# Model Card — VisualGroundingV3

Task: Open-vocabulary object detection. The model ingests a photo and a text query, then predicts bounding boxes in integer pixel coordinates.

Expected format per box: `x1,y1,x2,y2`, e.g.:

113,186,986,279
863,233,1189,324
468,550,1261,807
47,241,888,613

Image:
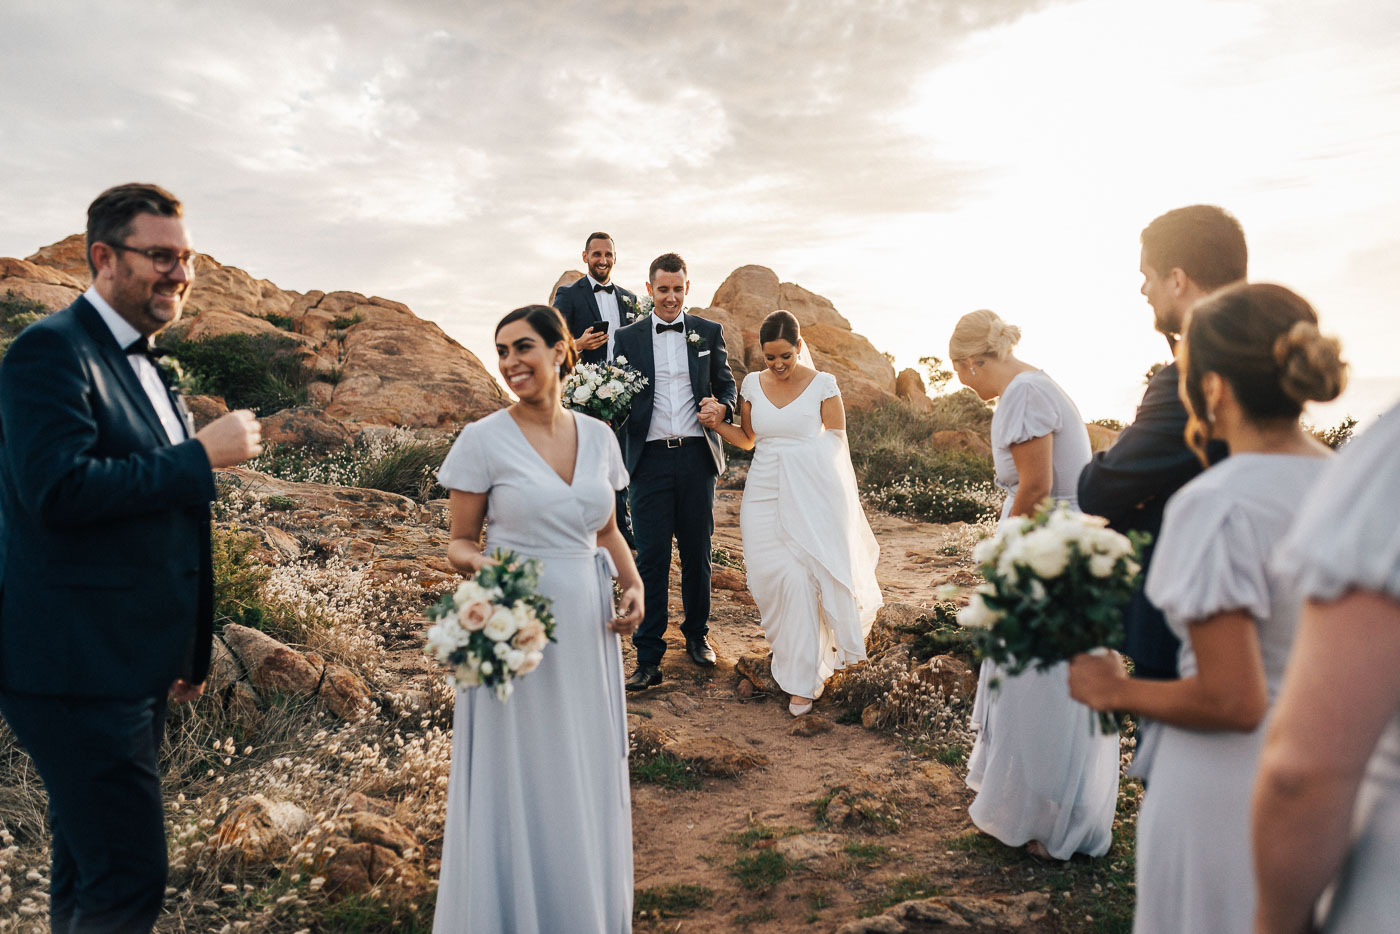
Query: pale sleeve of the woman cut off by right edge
1273,405,1400,601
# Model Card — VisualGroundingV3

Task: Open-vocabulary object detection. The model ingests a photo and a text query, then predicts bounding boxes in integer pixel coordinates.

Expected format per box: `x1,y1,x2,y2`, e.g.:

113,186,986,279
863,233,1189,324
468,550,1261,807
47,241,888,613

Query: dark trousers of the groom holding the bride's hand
629,438,714,665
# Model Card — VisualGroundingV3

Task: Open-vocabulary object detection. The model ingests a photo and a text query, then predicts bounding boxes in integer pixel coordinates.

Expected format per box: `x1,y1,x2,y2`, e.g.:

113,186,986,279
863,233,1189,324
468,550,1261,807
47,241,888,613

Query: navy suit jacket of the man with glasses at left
0,298,216,699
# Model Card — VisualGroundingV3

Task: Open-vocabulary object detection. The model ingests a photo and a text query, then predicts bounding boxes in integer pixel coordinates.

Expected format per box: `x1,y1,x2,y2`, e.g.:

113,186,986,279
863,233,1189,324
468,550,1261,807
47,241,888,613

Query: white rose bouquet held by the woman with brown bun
958,503,1147,732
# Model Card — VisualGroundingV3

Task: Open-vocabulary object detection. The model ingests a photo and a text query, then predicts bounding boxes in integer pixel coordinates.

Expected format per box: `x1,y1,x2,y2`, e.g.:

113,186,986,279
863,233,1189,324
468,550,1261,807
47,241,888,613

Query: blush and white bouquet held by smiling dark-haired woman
423,549,554,702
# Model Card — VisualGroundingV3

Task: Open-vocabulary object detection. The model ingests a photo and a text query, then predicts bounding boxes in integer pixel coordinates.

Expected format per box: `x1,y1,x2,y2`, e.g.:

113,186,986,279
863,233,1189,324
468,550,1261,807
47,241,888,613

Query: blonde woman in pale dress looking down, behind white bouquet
948,311,1119,860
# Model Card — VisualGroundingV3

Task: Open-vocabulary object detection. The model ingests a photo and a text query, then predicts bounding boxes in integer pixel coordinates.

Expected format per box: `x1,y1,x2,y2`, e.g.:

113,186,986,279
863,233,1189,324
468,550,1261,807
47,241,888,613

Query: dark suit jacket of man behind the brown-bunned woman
1079,363,1225,678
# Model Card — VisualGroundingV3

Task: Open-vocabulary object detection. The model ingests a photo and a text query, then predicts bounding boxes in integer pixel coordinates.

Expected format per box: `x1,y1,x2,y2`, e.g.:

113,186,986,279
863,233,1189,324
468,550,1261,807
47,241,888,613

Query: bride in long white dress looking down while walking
701,309,885,717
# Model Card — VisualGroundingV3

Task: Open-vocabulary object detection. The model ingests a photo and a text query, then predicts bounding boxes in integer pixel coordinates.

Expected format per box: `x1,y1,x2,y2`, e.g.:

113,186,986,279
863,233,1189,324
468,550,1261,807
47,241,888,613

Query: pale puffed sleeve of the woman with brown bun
1147,483,1270,627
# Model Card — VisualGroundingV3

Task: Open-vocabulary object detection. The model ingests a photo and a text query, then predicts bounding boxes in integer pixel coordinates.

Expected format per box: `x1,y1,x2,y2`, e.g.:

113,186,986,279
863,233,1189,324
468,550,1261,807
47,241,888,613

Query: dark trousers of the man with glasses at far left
0,693,167,934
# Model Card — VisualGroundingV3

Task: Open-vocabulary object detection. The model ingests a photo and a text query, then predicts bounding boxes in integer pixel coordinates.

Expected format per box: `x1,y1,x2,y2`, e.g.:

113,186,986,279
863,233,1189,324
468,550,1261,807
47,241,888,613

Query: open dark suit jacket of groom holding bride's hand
615,312,736,475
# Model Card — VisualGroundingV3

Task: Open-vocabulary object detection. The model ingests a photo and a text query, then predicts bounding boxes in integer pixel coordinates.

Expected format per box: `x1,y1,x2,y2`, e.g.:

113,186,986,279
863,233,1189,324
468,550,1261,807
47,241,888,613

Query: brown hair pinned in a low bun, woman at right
1179,283,1347,459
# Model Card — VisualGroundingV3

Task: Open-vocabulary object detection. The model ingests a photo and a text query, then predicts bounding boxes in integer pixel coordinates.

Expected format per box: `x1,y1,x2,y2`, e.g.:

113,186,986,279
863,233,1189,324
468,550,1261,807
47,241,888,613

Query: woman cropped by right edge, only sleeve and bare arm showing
1254,394,1400,934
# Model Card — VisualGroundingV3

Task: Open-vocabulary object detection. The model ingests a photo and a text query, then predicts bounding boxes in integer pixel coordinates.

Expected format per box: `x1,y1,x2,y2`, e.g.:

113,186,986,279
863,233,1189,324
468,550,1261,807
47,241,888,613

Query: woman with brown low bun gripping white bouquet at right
1070,284,1344,934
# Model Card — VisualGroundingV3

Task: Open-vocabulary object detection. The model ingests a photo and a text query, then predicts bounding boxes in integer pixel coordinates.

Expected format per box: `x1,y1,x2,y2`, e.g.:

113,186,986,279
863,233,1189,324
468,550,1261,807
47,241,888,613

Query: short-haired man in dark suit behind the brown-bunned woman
1079,204,1249,678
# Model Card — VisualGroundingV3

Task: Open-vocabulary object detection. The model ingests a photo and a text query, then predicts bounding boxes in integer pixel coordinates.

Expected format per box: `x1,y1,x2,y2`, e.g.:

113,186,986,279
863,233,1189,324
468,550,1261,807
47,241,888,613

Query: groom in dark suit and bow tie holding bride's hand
616,253,736,690
